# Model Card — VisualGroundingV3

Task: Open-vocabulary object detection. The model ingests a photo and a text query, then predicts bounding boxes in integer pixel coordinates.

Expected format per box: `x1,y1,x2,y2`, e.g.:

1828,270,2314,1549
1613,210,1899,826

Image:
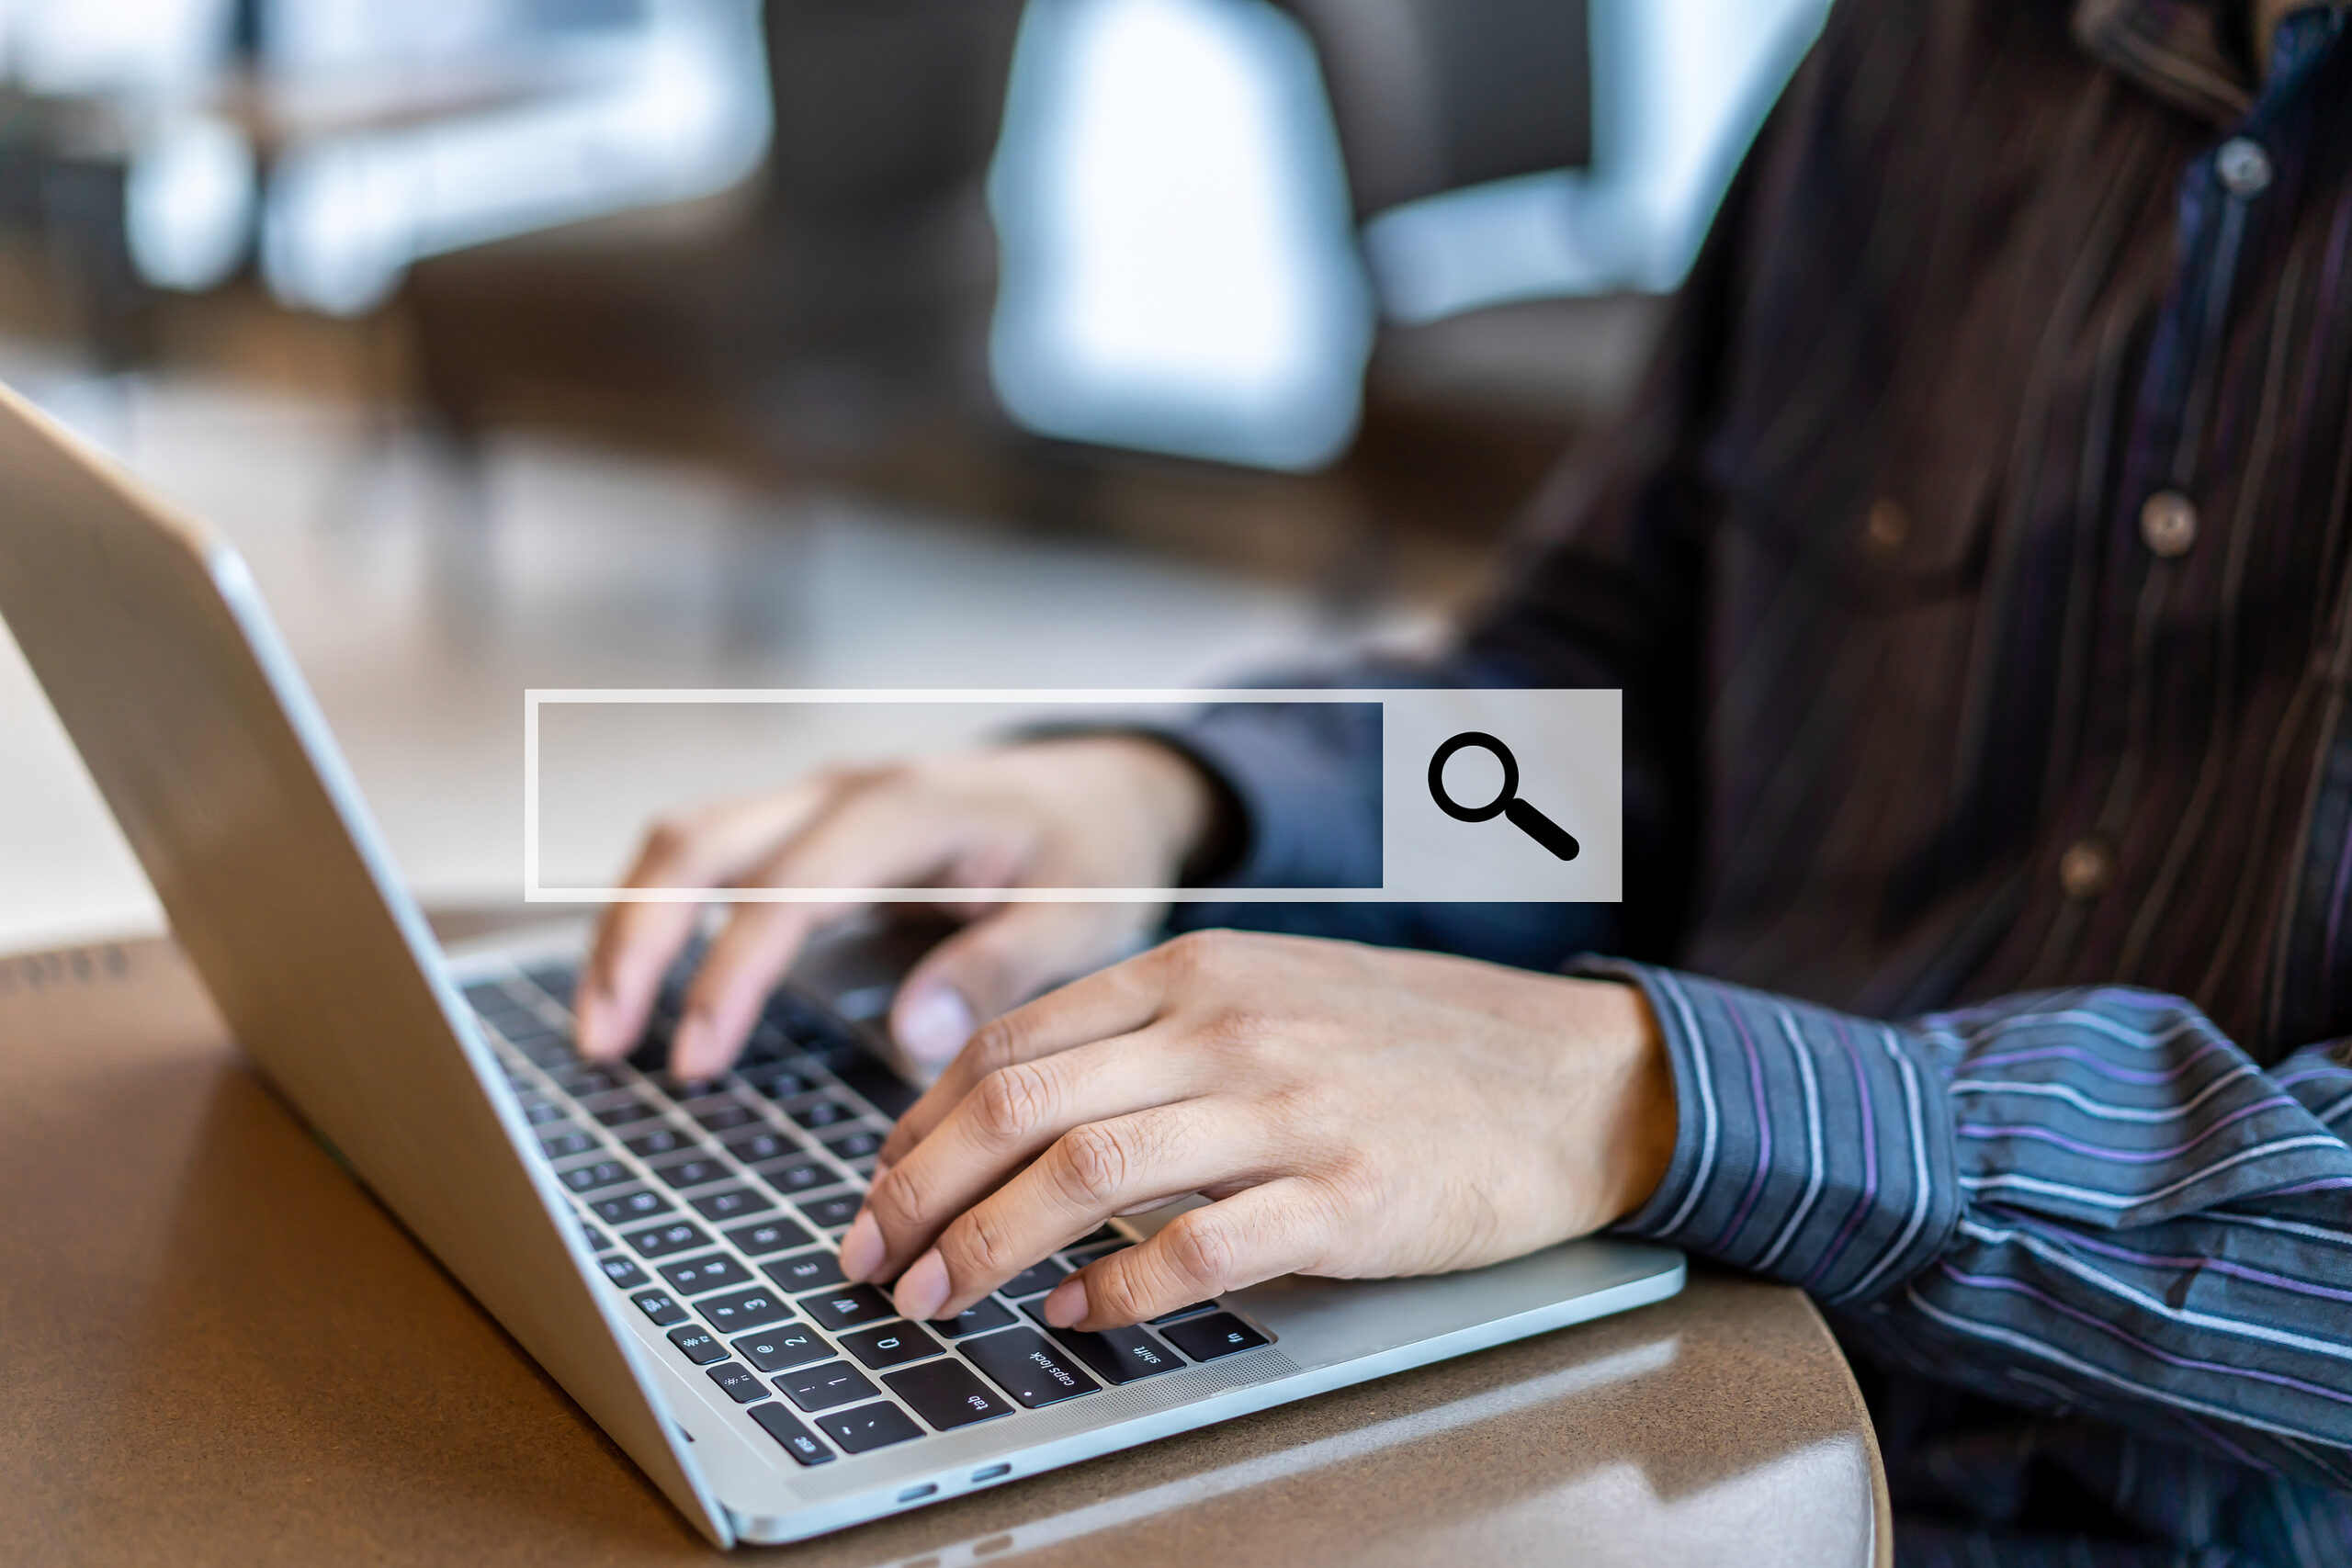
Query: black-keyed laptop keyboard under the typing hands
466,964,1268,1464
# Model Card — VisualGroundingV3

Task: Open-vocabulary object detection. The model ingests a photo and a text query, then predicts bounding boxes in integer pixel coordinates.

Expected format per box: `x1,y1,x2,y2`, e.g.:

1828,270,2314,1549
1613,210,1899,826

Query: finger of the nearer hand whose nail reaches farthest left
842,1034,1204,1279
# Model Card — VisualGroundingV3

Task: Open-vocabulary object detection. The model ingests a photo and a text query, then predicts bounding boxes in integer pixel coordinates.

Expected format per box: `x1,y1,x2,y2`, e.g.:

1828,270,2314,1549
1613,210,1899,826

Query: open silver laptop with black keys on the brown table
0,390,1684,1547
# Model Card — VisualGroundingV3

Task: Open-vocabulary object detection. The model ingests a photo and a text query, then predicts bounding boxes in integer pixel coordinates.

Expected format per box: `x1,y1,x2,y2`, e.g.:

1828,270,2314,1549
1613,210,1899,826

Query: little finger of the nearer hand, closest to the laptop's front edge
1045,1176,1345,1331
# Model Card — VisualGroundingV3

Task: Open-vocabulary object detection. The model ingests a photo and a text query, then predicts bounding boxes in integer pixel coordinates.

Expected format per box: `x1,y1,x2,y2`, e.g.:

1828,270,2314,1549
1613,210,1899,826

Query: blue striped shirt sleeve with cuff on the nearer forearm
1580,962,2352,1488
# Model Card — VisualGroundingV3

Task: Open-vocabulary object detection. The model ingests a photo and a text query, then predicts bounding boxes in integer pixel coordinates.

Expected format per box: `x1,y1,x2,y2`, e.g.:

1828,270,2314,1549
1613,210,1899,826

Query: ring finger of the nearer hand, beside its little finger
894,1100,1270,1321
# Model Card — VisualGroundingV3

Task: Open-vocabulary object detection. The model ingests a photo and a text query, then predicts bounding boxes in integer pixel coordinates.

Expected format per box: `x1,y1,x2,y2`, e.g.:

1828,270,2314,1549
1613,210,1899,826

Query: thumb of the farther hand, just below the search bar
889,903,1150,1067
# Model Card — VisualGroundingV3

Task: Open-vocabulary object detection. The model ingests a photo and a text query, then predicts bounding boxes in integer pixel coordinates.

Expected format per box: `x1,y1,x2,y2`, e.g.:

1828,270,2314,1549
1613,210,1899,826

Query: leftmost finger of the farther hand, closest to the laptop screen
574,778,837,1060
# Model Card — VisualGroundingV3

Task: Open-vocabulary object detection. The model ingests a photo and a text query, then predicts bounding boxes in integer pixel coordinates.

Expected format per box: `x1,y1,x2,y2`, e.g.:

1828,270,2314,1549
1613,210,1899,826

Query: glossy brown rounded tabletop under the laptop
0,926,1889,1568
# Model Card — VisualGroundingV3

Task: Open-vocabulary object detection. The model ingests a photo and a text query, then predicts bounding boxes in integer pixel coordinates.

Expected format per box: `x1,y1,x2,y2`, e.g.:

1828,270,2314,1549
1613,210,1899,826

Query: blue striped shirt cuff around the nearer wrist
1571,959,1964,1304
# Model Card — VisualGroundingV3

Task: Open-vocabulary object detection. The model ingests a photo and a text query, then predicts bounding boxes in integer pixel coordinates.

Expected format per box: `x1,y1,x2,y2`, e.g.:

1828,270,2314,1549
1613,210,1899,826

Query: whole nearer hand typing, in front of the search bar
842,931,1675,1328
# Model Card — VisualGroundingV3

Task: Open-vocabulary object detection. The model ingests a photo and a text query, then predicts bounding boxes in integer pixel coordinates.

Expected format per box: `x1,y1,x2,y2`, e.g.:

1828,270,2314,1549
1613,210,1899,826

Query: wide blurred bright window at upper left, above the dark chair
261,0,769,315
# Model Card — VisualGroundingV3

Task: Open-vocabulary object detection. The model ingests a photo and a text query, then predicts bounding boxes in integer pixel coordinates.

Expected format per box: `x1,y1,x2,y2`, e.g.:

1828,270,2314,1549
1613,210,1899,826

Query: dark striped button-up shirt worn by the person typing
1179,0,2352,1563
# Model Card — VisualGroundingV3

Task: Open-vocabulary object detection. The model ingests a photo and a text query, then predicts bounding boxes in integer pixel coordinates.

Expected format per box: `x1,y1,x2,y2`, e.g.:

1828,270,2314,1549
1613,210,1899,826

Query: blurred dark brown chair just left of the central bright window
404,0,1021,468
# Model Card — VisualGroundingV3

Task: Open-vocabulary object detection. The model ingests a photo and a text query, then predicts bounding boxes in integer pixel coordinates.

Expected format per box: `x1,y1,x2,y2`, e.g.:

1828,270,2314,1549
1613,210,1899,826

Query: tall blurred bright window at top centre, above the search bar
990,0,1371,468
